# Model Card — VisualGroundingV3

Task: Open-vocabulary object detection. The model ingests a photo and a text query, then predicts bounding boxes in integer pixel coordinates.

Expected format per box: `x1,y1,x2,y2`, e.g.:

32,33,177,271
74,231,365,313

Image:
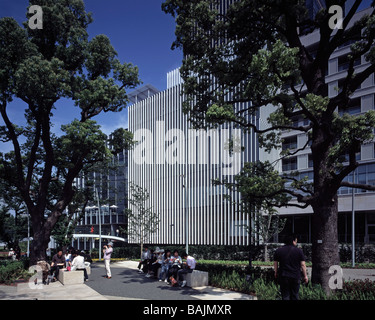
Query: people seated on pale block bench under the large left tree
50,248,91,281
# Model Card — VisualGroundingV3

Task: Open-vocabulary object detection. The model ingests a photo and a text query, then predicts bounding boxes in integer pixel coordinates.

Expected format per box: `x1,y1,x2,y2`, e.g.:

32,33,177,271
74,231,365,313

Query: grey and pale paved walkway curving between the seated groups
0,261,253,300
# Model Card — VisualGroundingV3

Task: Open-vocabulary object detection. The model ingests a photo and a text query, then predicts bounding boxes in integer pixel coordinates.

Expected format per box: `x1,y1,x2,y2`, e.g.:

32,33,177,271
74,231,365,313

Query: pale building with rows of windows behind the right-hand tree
274,9,375,243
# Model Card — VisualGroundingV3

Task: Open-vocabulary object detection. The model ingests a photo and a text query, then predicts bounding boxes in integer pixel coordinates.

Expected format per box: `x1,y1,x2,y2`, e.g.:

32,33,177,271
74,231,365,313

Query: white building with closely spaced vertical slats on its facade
129,70,267,245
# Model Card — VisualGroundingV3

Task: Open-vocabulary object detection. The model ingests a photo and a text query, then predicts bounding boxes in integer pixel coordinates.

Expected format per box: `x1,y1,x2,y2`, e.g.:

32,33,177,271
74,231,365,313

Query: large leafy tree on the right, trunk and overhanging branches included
163,0,375,292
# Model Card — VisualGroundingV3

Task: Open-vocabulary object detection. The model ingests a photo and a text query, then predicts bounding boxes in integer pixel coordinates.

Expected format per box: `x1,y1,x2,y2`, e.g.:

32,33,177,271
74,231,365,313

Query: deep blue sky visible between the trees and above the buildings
0,0,182,152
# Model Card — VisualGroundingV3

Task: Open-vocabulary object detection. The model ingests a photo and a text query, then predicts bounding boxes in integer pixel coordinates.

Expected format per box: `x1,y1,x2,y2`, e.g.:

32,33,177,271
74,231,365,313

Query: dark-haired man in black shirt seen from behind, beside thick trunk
274,235,309,300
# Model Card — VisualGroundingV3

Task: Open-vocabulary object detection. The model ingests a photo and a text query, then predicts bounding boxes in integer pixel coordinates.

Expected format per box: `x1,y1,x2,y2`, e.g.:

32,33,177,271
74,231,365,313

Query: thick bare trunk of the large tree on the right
311,195,340,294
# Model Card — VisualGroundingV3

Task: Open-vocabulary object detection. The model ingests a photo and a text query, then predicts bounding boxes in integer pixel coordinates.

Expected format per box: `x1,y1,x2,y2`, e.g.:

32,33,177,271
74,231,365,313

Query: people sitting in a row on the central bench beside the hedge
138,247,196,287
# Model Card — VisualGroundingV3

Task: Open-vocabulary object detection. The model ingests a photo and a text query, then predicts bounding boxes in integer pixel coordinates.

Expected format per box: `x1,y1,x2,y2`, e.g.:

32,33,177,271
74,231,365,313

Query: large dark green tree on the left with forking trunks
0,0,140,264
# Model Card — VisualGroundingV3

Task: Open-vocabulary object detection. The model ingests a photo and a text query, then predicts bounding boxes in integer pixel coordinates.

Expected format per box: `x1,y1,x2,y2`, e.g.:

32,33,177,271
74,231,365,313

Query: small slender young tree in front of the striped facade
126,183,160,259
